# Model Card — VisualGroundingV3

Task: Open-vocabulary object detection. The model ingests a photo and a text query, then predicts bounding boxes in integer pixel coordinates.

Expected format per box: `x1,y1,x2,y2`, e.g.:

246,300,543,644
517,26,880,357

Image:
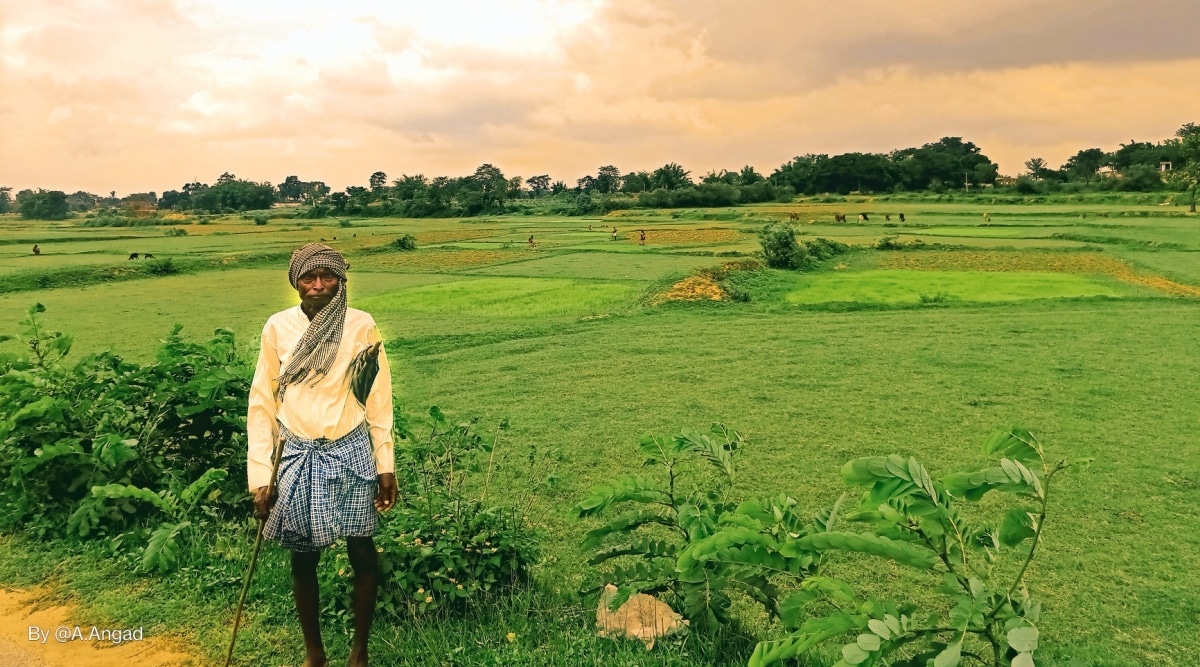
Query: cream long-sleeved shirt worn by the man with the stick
246,306,395,491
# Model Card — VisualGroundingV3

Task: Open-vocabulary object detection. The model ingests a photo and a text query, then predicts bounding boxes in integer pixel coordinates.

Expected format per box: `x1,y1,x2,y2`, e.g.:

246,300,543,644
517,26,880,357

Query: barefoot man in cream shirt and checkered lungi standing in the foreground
246,244,396,667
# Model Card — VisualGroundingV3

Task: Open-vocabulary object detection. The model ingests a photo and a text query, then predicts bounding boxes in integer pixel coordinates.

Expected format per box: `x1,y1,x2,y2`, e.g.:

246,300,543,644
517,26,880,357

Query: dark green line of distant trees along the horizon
0,122,1200,220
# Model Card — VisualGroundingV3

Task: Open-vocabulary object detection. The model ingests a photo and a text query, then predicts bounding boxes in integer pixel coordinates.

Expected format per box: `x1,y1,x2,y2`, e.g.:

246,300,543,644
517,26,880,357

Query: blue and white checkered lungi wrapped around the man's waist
263,422,378,552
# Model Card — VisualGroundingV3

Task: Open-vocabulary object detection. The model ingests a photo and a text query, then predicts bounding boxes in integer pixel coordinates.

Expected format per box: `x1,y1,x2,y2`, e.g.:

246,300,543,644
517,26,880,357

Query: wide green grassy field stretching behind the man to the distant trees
0,194,1200,667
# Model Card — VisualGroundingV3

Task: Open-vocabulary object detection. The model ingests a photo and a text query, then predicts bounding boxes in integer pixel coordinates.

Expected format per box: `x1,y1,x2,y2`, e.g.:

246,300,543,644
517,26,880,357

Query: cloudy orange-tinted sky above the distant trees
0,0,1200,196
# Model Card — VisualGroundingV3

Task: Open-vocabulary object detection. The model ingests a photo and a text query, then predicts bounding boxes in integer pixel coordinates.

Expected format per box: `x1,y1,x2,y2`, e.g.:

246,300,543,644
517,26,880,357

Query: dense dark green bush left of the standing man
0,304,254,536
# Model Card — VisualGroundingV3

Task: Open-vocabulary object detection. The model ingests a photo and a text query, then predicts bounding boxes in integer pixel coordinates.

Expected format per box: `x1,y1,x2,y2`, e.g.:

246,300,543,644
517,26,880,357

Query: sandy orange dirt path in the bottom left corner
0,588,199,667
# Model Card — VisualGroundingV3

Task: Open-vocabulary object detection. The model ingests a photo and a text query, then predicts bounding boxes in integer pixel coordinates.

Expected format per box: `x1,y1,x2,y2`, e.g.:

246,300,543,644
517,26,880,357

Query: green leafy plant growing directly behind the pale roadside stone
576,423,835,629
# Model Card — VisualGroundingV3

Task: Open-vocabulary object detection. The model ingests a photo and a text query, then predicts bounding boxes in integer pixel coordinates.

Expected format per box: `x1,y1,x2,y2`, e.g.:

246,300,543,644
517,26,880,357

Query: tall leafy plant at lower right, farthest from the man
749,428,1070,667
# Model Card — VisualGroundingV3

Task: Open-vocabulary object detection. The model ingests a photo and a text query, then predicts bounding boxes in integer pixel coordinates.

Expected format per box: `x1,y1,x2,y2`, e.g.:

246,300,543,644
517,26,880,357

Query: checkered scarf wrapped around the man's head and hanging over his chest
278,244,349,402
